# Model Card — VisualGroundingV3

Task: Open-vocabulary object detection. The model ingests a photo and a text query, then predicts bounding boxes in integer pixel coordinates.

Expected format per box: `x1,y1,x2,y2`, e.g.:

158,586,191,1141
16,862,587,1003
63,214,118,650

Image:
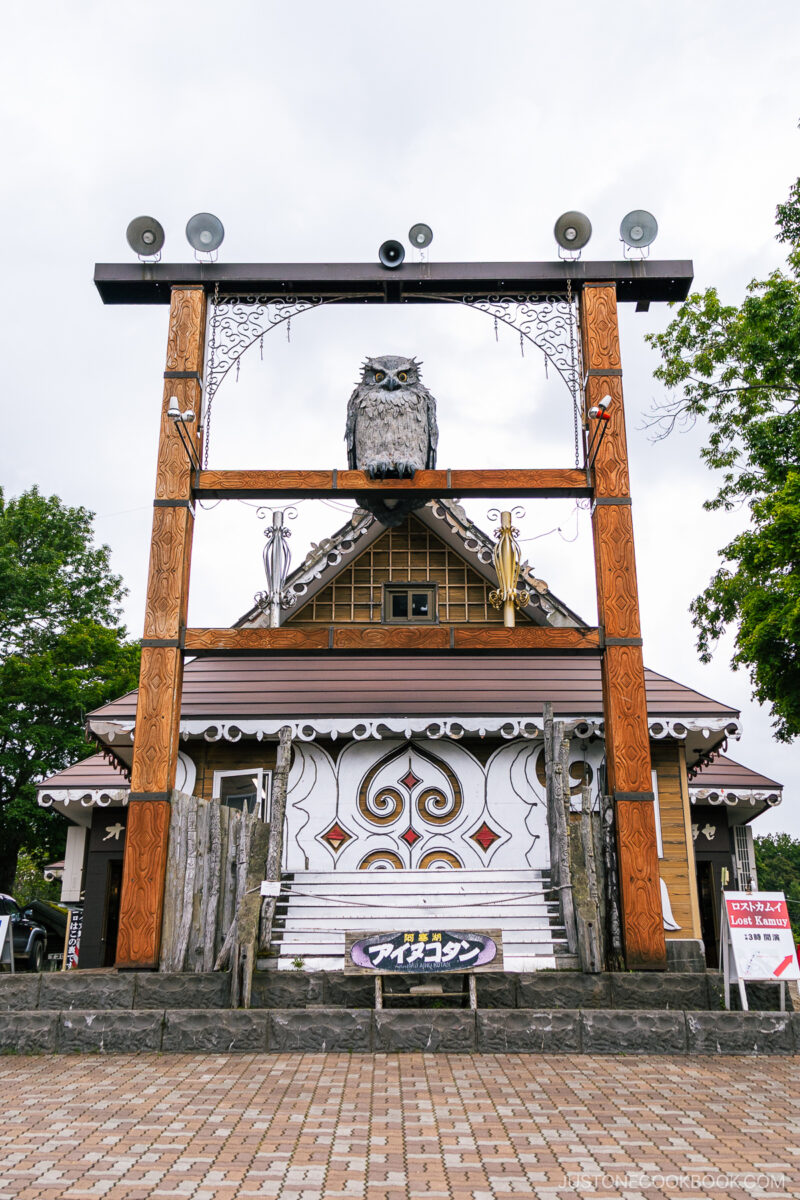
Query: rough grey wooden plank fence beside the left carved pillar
160,792,267,971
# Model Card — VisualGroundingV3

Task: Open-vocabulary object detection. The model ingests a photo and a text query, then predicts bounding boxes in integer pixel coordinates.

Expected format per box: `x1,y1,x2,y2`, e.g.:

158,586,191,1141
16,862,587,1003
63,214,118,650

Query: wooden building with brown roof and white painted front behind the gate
40,500,781,970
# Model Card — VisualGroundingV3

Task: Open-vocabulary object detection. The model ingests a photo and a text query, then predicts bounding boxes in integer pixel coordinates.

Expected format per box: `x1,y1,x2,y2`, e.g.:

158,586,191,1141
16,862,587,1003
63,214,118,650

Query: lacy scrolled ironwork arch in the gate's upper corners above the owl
204,292,583,466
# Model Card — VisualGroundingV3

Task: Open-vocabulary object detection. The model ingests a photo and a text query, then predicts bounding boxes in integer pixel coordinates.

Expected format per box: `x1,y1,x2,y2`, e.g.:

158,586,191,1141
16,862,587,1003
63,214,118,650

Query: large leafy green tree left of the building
0,487,139,892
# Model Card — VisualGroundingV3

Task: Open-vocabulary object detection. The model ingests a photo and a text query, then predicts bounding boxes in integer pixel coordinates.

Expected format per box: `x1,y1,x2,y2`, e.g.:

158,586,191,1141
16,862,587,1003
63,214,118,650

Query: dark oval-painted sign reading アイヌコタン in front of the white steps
344,929,503,974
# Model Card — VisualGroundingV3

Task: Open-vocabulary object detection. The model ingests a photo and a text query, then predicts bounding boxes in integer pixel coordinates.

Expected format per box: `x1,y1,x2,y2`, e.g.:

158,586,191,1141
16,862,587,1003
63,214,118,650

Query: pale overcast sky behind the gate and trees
0,0,800,836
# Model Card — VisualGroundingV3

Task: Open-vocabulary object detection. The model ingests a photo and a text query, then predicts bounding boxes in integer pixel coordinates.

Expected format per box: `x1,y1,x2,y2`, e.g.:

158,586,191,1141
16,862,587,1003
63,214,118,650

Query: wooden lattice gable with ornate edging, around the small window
237,500,585,628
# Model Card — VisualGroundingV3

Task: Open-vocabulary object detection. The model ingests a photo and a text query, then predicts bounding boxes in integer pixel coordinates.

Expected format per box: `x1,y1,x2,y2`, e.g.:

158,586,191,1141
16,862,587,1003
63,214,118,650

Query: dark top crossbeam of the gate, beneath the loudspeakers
95,259,694,305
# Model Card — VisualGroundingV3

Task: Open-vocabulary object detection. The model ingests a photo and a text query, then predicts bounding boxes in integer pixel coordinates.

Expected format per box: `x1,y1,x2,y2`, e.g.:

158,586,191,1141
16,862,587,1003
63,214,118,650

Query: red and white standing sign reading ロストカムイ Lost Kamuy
723,892,800,980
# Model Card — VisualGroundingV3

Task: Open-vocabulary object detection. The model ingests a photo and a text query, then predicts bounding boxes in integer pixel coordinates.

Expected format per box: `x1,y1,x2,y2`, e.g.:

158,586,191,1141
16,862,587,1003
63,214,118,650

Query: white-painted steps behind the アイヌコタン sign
259,870,568,972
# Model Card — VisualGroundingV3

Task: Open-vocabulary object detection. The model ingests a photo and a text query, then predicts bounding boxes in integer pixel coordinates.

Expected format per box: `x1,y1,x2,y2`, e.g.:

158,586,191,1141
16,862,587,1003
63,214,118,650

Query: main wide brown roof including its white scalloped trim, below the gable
89,652,739,764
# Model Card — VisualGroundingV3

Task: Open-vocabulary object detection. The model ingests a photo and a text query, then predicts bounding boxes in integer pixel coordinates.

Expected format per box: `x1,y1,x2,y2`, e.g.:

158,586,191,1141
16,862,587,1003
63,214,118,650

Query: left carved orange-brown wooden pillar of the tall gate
116,287,206,968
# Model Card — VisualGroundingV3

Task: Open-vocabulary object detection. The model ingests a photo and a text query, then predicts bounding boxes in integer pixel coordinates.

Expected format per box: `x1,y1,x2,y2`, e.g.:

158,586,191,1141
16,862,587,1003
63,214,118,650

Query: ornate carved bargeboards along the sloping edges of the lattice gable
236,500,587,629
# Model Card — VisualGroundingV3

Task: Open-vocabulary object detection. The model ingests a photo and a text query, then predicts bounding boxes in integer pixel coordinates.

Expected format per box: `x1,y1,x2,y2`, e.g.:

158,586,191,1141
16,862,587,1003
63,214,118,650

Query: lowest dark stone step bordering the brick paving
0,1008,800,1056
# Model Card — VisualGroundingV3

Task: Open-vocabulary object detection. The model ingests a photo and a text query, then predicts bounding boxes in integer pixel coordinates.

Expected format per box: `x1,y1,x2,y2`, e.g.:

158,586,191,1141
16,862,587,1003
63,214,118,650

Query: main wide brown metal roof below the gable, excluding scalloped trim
90,653,739,720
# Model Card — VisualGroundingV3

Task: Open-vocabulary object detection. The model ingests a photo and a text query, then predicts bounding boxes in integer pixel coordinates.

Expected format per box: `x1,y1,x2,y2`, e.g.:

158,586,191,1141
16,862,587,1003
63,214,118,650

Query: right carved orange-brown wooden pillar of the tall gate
581,283,667,970
